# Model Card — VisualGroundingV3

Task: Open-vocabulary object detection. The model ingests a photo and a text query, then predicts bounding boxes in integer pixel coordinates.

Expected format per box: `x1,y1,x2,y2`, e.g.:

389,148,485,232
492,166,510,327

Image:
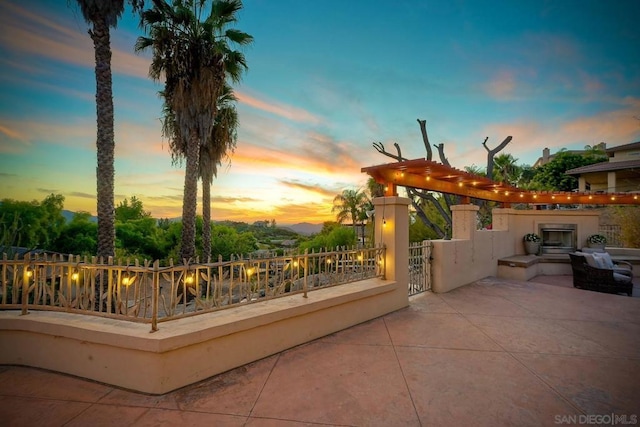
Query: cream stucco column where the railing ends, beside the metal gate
373,196,411,284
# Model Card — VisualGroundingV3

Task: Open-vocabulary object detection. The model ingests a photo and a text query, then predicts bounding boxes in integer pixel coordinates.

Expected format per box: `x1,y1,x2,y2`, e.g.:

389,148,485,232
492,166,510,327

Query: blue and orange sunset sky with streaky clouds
0,0,640,224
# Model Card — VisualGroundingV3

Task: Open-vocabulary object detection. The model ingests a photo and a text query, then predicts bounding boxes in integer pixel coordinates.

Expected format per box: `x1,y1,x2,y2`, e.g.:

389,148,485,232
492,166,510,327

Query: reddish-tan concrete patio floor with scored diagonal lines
0,276,640,427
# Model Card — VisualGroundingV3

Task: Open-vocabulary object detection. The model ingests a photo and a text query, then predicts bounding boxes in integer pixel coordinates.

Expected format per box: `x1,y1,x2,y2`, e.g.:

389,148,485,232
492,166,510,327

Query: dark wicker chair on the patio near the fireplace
569,254,633,296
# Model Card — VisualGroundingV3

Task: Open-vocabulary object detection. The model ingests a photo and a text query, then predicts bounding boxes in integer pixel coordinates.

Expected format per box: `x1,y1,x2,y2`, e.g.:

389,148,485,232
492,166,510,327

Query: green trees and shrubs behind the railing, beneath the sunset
0,194,357,263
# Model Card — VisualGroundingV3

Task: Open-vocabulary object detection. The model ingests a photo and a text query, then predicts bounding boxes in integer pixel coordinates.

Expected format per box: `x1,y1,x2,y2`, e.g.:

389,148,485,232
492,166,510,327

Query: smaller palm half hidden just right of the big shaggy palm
199,85,238,261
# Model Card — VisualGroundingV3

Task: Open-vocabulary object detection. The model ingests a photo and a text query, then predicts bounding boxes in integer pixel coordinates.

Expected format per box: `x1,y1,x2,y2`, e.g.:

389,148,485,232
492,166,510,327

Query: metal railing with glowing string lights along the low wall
0,247,385,331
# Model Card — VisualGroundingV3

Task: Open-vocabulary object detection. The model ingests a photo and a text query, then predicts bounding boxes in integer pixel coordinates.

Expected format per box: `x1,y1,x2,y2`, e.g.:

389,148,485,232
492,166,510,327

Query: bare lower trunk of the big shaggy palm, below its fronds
180,130,200,261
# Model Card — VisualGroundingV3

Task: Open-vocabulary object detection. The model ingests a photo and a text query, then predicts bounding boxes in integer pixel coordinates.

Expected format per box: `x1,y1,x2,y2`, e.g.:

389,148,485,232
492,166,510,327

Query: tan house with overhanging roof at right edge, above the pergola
566,141,640,193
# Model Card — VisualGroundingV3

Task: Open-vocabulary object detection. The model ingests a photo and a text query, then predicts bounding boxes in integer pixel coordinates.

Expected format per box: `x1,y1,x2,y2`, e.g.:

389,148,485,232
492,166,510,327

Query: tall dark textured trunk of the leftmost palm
89,18,115,258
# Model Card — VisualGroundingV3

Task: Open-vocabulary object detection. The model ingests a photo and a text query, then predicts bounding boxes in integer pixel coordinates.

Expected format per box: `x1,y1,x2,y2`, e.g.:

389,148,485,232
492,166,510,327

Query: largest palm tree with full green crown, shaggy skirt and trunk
136,0,253,261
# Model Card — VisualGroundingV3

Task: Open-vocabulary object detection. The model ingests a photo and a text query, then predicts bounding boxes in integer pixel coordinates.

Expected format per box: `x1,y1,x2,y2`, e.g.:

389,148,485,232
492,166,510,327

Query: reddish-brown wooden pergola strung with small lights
361,159,640,207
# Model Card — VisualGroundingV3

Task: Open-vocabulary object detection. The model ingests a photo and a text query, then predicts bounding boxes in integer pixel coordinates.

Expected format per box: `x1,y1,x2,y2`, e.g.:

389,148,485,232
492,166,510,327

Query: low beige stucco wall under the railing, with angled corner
0,279,408,394
